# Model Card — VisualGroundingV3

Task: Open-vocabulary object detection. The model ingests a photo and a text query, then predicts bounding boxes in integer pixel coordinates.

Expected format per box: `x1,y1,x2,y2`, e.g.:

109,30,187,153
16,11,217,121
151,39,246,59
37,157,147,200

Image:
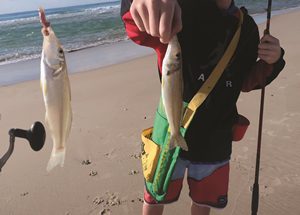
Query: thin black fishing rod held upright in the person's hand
251,0,272,215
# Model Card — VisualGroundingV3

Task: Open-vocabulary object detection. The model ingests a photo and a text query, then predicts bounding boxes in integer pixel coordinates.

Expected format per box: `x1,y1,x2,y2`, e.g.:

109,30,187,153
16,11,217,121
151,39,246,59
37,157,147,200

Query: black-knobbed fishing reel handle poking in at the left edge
0,122,46,172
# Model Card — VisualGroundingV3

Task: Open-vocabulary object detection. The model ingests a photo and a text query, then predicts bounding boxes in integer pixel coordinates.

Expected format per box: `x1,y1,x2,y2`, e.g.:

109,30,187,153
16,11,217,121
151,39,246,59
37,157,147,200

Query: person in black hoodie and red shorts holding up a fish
121,0,285,215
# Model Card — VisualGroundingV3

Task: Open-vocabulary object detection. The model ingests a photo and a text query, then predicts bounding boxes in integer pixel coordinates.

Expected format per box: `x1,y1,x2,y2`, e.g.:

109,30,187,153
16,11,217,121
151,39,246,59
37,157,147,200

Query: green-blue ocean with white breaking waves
0,0,300,66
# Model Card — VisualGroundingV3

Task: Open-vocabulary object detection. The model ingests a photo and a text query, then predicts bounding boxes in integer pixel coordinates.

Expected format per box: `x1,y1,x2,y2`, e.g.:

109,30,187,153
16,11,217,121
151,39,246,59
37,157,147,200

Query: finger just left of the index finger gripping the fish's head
149,1,159,37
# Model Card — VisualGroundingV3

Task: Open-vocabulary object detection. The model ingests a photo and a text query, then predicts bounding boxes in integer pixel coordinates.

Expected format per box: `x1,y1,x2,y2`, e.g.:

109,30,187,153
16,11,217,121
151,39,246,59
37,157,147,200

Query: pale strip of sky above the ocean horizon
0,0,108,14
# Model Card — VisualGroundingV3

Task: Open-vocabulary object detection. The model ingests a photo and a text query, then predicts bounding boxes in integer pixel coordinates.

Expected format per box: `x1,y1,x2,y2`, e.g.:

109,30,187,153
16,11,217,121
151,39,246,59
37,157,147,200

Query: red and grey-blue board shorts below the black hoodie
144,158,229,208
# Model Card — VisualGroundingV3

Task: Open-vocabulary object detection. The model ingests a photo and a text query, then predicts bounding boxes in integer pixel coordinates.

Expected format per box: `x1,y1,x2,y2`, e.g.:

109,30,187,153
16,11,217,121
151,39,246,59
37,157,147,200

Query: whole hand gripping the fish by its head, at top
130,0,182,43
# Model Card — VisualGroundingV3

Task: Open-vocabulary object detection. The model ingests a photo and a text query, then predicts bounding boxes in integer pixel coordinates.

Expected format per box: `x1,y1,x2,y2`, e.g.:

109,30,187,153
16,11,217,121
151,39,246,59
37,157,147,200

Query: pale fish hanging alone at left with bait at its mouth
39,8,72,172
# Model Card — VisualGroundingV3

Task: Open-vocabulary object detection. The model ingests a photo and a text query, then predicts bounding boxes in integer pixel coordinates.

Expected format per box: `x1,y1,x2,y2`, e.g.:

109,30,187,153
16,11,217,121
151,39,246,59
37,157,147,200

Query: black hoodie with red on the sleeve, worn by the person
121,0,285,163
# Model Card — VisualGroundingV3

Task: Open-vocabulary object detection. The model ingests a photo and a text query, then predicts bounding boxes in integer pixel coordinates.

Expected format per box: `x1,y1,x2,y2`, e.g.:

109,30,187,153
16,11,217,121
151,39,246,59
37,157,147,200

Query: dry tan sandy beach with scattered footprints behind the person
0,10,300,215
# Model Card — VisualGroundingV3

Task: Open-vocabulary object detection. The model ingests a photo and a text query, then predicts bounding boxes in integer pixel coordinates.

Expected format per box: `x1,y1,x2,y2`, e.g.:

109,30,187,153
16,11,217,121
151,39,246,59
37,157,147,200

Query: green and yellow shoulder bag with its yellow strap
141,11,243,202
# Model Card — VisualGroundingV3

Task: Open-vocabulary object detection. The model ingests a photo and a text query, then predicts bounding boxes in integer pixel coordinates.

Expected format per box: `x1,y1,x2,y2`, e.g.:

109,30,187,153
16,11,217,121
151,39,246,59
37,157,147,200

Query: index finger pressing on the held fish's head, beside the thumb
159,7,174,43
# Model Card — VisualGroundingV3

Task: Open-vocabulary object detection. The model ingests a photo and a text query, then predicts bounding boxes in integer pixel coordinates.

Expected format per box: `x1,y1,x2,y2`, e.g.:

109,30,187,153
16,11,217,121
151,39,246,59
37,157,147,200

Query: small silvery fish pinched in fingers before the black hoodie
161,35,188,151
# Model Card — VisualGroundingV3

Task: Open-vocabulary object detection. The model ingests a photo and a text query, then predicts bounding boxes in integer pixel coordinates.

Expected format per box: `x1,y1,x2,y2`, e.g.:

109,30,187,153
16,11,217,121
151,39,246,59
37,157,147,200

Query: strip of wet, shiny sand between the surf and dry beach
0,7,300,87
